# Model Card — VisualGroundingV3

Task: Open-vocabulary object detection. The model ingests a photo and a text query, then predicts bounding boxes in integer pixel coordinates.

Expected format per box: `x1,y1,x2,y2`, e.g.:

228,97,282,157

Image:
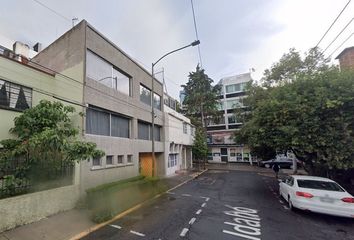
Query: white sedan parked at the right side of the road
279,175,354,218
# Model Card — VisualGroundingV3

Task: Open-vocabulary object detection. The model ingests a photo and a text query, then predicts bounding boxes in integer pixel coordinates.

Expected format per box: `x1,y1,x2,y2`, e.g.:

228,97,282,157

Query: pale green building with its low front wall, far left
0,44,83,232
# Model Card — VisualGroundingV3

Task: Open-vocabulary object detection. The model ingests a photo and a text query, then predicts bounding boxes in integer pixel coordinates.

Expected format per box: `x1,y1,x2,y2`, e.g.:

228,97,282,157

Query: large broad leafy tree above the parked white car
238,49,354,175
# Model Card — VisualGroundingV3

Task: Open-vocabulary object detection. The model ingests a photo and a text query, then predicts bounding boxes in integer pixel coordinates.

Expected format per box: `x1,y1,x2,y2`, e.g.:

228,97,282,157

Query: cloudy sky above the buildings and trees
0,0,354,99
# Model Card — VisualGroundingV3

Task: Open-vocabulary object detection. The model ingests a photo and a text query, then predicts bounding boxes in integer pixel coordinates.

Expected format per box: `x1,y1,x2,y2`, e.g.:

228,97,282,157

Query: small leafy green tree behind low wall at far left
0,100,104,195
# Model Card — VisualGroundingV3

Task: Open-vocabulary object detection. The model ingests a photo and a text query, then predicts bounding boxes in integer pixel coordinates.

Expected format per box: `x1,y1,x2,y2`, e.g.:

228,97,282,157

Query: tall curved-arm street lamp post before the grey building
151,40,200,176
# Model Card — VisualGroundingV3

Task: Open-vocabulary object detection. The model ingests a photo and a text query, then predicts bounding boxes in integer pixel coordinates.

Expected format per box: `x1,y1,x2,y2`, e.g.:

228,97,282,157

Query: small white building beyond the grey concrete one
164,95,195,176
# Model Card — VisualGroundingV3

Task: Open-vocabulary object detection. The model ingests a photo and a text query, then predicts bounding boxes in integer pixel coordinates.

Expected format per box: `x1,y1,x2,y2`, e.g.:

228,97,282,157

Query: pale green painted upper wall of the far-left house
0,56,83,140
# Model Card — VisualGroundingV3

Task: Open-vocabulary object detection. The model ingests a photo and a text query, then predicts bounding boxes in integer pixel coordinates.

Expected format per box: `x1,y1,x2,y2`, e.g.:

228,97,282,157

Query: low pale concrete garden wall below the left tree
0,185,79,232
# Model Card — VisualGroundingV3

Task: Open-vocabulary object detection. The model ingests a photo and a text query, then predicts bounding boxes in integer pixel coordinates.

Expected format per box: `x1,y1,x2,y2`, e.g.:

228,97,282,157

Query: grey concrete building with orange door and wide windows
32,20,164,191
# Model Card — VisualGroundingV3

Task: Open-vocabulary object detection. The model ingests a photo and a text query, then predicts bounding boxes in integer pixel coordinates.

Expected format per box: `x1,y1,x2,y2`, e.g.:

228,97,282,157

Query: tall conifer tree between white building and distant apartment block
182,65,221,128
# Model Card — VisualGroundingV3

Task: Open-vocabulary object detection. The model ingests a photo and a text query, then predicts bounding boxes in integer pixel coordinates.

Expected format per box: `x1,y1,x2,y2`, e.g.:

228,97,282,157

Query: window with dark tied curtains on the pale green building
0,79,32,110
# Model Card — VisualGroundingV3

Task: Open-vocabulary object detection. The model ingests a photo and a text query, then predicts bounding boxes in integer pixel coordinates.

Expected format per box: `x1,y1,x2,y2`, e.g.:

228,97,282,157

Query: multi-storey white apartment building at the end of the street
207,73,255,164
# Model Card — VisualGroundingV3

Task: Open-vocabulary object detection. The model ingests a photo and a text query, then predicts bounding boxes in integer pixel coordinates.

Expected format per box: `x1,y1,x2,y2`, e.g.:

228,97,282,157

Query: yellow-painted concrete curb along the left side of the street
69,169,208,240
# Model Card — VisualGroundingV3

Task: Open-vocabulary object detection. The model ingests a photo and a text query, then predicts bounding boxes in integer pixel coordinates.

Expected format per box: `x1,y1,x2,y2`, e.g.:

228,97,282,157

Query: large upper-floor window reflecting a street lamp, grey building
86,50,130,96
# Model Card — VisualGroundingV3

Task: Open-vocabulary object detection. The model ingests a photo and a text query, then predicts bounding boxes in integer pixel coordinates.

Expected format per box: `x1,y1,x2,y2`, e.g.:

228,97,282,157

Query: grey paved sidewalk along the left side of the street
0,171,200,240
